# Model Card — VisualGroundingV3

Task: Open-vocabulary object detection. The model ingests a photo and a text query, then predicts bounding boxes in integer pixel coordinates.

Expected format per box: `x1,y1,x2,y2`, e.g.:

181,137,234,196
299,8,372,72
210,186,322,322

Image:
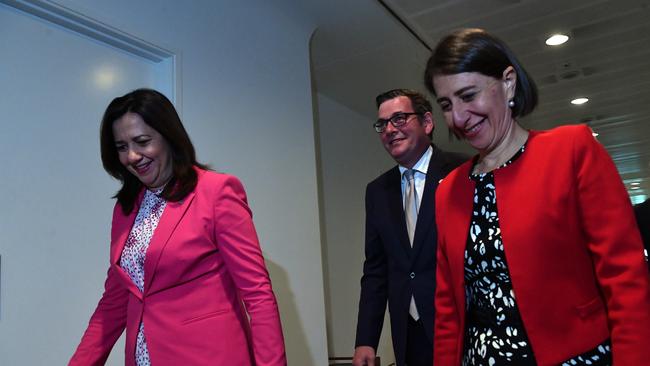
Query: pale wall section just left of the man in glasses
317,93,395,365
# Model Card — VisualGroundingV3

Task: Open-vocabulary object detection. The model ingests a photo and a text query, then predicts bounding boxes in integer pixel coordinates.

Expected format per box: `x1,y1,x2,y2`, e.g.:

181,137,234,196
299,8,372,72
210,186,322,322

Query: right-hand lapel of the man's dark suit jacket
412,146,447,258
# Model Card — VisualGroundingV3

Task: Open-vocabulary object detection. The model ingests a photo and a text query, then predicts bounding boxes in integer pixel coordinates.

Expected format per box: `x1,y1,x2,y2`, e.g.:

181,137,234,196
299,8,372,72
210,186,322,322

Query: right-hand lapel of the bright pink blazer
144,192,194,293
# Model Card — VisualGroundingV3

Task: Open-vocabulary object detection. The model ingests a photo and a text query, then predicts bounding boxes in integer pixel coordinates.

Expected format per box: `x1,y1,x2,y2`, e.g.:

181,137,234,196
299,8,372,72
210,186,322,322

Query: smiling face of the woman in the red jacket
433,67,516,153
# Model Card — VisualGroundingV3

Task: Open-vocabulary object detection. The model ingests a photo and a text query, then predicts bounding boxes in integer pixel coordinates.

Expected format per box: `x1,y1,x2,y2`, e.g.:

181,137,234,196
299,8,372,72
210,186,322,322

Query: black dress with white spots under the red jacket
463,145,611,366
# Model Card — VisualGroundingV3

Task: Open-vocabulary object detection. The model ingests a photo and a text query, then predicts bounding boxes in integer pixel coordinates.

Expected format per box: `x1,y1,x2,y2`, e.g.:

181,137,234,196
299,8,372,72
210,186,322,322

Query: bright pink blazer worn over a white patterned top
69,170,287,366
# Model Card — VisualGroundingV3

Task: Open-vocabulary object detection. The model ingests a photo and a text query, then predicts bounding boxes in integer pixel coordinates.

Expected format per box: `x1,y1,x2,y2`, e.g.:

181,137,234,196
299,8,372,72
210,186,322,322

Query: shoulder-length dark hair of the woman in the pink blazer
99,89,208,214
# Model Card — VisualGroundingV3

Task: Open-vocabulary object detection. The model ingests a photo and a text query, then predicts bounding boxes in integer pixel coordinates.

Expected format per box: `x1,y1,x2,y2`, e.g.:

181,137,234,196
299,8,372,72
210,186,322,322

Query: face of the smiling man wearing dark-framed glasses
377,96,433,168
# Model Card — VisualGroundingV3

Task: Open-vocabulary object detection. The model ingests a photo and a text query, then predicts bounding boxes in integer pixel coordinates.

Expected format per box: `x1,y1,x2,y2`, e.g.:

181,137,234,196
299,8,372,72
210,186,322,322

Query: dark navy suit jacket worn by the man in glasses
356,146,467,365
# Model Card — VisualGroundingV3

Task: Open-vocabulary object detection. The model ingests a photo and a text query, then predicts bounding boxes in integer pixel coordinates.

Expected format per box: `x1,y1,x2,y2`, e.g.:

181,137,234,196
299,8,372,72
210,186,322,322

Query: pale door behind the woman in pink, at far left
0,2,173,365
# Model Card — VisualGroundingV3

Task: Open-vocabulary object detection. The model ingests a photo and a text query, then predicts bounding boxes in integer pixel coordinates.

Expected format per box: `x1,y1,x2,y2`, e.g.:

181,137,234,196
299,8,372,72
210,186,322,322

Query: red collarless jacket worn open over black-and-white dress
434,125,650,366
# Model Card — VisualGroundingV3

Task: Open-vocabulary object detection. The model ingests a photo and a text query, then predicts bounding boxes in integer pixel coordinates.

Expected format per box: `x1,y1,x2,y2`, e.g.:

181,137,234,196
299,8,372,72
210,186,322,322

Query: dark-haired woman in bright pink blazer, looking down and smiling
69,89,286,366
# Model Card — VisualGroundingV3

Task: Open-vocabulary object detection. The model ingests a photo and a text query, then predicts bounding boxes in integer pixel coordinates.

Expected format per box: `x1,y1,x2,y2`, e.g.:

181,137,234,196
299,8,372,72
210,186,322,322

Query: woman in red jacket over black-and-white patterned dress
425,29,650,366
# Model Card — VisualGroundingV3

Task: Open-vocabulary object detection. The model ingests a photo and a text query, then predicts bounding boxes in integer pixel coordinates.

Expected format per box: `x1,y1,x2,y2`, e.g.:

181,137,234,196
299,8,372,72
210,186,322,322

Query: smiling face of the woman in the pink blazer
113,112,172,189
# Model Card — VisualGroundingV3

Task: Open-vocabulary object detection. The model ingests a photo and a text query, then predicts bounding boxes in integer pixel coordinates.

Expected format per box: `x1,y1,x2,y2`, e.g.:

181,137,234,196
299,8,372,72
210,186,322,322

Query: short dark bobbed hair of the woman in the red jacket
424,28,538,117
